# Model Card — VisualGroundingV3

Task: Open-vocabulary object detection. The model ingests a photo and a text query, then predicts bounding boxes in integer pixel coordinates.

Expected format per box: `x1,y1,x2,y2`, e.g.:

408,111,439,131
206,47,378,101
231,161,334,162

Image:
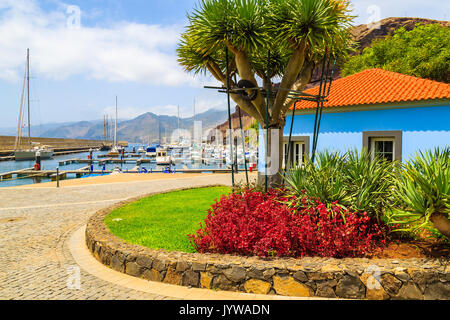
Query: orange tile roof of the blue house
291,69,450,110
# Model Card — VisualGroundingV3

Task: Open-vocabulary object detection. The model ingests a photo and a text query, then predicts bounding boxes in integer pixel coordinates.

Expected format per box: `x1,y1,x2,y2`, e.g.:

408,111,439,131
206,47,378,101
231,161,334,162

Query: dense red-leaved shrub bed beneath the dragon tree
189,189,385,258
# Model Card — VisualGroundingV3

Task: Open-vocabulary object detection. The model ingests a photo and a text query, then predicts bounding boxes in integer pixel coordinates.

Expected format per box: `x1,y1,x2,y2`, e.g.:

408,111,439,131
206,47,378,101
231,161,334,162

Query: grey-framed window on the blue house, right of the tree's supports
363,131,402,161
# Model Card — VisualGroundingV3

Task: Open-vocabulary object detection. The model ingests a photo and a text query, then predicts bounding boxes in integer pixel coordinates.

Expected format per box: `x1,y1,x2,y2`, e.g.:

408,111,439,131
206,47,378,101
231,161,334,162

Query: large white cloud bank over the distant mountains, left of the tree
0,0,198,86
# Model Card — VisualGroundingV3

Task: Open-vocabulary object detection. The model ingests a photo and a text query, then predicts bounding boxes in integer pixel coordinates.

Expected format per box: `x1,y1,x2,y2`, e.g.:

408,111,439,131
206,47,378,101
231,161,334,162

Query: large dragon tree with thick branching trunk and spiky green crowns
177,0,353,185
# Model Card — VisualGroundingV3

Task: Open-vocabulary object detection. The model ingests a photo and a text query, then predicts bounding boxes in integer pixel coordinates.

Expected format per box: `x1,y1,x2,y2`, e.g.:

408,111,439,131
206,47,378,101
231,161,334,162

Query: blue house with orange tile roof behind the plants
284,69,450,164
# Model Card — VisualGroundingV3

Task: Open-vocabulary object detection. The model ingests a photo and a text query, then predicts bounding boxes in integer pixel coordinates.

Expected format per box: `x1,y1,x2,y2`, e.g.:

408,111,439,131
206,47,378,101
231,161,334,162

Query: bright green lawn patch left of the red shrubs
105,187,231,252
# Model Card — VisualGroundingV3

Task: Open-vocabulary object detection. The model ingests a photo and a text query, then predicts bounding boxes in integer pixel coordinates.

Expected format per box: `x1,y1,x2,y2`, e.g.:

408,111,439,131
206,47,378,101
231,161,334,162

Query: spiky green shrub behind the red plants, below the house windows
285,149,398,219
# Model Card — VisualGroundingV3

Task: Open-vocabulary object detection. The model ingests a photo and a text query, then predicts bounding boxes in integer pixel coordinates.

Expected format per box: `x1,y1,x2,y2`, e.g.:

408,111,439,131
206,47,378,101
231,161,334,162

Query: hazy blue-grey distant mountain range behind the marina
41,109,227,143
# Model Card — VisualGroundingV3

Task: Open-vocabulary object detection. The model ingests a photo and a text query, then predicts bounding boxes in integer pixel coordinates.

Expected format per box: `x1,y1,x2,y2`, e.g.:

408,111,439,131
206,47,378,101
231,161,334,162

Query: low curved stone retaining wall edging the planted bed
86,192,450,300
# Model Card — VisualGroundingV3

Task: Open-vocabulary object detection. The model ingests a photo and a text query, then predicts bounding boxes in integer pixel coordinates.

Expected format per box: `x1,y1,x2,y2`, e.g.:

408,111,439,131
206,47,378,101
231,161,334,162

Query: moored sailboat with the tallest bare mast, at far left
14,49,54,161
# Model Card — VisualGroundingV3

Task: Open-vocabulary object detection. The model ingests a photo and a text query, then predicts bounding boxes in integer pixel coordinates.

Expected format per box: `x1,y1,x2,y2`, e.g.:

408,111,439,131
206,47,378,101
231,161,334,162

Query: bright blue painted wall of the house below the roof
284,105,450,160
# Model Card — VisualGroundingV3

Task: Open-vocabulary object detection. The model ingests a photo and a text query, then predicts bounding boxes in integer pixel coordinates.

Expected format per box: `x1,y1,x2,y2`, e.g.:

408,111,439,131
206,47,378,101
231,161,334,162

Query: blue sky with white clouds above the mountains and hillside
0,0,450,127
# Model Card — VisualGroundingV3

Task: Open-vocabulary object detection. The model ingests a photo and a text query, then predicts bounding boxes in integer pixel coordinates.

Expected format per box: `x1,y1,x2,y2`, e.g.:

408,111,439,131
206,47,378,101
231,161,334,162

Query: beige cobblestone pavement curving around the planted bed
0,175,237,300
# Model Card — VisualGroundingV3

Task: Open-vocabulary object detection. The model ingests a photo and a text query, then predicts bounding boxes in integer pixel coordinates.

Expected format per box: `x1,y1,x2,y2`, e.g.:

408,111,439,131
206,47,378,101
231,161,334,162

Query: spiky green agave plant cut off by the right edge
387,147,450,238
